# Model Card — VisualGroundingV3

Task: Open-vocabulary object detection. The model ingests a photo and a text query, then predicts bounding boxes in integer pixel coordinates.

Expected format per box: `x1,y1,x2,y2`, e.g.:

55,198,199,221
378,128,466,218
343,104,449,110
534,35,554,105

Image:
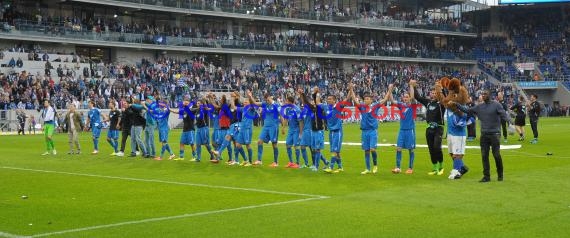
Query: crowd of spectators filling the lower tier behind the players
0,44,506,115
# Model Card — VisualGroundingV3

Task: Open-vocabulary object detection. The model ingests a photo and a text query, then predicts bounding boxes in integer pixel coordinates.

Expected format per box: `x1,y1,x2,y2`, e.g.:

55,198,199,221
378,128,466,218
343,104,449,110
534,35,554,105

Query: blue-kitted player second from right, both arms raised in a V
351,84,393,174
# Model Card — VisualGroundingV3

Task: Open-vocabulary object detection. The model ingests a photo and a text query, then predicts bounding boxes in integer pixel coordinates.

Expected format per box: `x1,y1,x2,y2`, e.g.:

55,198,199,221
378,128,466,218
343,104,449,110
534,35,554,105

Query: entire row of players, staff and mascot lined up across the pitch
36,80,540,182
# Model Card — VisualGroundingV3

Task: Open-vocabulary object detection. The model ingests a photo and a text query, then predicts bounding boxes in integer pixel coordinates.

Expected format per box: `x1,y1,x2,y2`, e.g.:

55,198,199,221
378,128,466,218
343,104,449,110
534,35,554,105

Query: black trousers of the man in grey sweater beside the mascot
480,132,503,178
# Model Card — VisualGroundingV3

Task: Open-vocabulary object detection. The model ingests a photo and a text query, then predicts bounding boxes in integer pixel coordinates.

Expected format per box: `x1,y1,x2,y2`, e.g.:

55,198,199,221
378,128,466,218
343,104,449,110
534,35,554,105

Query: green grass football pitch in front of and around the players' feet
0,118,570,237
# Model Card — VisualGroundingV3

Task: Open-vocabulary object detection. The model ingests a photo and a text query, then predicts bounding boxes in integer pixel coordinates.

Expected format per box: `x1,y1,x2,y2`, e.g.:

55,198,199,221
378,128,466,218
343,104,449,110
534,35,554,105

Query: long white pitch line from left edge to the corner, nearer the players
0,166,329,198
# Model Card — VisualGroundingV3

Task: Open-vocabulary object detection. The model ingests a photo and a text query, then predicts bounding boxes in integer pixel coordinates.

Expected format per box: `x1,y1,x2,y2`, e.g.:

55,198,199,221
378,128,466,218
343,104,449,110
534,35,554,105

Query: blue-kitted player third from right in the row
325,84,353,173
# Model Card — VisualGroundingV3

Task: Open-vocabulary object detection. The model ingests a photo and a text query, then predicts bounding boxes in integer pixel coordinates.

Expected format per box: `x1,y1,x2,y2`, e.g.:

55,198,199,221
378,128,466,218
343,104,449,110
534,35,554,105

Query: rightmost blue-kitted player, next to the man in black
390,87,417,174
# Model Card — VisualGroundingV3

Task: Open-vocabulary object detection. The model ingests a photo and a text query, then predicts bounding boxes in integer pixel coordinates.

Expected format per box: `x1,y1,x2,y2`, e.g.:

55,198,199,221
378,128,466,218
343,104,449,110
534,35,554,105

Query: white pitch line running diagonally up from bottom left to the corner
31,197,326,237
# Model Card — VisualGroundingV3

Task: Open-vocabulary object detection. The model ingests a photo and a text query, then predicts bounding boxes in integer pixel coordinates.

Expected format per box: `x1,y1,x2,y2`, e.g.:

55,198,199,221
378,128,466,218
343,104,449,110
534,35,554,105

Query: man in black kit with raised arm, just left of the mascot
410,80,445,175
